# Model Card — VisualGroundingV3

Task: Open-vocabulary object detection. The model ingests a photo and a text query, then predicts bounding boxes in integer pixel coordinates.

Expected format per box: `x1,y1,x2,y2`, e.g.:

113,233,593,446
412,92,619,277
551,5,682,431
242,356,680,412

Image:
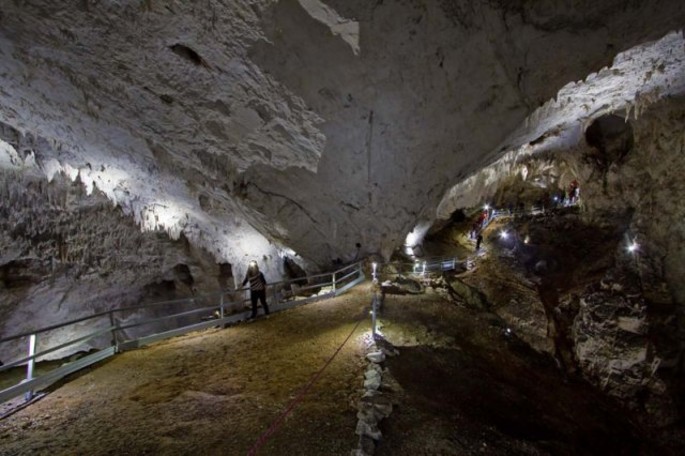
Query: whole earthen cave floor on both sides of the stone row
0,276,650,456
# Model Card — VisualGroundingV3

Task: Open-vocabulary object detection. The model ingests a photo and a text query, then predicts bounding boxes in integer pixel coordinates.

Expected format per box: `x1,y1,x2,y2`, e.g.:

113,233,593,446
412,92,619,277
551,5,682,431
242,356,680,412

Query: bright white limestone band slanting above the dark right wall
437,31,685,220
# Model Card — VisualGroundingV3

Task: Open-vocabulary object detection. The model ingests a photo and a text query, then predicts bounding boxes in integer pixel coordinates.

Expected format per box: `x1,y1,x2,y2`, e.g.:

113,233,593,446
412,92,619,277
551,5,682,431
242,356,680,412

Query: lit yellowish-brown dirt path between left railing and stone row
0,285,370,456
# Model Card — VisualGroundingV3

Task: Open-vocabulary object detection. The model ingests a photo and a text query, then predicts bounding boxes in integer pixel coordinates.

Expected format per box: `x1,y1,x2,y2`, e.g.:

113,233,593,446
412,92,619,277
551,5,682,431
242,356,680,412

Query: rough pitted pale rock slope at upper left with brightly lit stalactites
0,1,316,280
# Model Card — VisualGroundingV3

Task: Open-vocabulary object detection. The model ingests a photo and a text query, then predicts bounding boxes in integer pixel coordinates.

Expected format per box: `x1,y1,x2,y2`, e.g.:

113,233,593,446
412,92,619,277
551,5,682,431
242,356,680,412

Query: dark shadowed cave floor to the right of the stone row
376,294,658,456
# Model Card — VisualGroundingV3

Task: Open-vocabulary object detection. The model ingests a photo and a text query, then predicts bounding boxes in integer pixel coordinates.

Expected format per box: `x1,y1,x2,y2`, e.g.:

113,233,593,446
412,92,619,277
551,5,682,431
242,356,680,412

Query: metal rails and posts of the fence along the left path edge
0,261,364,402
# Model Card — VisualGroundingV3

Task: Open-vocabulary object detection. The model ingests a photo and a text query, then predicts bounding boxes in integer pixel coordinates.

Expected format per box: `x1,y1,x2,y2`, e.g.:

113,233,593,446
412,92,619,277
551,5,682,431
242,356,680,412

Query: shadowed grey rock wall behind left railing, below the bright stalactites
0,170,227,359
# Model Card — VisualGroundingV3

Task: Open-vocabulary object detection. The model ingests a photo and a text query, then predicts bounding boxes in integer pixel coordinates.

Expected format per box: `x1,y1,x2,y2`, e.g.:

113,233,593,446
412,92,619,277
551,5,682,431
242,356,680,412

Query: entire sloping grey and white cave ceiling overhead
0,0,685,267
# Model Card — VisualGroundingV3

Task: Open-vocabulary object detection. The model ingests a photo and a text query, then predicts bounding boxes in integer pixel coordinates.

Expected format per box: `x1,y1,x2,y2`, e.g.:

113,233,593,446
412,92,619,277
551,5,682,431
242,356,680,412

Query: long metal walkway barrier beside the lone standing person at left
0,262,365,403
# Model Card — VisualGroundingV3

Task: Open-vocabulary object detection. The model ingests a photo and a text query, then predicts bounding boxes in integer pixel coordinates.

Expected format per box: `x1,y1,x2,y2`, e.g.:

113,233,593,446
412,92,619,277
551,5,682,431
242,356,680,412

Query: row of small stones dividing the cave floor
350,346,399,456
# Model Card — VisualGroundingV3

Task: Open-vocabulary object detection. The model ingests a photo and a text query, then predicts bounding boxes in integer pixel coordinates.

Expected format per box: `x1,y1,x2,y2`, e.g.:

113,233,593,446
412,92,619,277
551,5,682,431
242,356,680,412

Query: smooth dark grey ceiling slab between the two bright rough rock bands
245,1,684,262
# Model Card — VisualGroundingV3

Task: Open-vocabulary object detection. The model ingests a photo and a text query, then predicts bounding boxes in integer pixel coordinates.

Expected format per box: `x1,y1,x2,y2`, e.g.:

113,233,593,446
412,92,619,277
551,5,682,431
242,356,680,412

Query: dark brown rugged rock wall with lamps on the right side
454,97,685,429
